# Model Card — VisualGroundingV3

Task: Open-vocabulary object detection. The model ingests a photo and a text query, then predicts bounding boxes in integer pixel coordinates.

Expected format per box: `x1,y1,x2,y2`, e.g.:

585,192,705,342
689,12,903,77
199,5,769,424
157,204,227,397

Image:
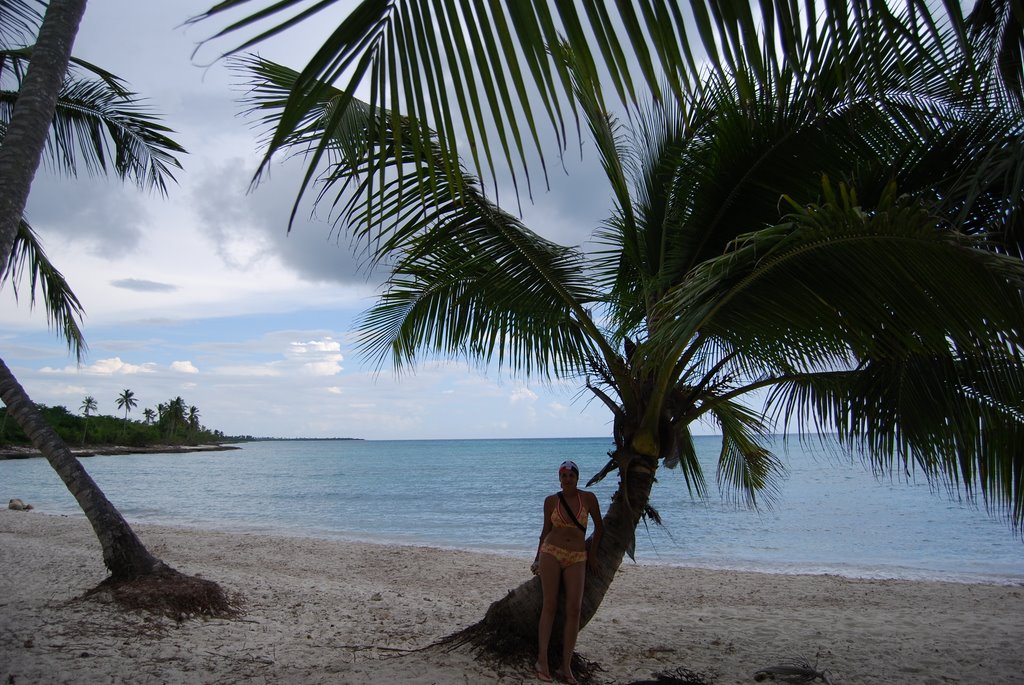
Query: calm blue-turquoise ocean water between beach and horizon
0,436,1024,584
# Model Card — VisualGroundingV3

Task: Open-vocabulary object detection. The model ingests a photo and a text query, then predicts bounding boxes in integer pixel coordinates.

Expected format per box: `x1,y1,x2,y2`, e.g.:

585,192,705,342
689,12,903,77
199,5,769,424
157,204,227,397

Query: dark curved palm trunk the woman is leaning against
452,449,657,663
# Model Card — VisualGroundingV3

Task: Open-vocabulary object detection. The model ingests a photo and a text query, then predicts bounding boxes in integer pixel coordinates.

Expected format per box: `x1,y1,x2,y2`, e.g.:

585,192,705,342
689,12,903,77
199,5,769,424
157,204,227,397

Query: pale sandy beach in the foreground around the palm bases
0,510,1024,685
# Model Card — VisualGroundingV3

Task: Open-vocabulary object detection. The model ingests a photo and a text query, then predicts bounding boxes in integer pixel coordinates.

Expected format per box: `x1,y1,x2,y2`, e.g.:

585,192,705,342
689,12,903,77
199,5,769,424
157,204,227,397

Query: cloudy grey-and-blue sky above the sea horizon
0,0,630,439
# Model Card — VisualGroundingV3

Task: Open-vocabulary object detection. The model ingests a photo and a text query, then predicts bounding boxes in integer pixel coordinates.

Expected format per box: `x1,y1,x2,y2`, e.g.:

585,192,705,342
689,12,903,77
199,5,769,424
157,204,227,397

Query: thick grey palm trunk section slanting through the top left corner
0,0,86,274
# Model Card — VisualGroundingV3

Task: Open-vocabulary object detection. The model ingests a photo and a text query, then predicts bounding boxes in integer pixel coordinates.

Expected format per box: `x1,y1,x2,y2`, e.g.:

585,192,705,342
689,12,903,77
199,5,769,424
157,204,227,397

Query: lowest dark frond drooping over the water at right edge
767,354,1024,528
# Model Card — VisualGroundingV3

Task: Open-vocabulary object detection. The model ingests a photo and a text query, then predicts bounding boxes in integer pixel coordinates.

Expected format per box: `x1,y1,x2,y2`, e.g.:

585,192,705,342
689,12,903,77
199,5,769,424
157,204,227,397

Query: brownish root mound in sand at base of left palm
85,566,239,620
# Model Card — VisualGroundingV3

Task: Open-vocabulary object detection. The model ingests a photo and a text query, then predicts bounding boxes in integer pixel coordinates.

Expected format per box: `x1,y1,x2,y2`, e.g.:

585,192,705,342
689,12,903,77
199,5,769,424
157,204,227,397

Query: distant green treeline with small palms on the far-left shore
0,398,241,447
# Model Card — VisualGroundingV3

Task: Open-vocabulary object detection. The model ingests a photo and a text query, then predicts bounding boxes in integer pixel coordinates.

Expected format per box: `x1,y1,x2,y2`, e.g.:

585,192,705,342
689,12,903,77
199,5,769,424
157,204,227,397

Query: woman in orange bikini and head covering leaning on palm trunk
531,462,603,684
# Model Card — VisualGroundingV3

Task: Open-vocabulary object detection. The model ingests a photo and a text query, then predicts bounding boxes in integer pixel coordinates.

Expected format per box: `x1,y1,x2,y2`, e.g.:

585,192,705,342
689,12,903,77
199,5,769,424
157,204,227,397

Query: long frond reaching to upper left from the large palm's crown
238,52,622,374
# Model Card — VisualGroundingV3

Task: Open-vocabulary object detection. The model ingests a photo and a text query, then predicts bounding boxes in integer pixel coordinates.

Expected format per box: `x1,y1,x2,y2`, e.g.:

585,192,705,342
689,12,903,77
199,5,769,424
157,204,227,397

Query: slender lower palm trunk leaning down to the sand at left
0,359,166,580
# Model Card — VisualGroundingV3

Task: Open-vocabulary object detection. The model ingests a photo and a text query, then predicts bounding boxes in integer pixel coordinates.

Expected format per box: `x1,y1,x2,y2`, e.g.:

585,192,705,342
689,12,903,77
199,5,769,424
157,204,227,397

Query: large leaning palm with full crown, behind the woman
232,2,1024,663
